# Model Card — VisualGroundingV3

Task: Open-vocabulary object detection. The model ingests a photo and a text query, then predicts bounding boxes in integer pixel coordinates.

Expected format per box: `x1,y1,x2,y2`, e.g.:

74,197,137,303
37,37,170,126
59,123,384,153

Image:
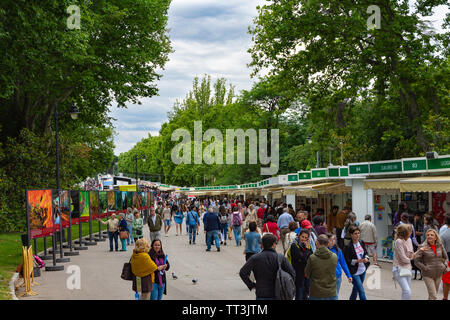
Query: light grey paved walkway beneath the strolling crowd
17,225,432,300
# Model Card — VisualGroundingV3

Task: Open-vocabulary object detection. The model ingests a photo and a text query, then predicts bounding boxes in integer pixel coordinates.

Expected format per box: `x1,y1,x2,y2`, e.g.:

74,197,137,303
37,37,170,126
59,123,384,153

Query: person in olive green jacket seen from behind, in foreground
305,234,338,300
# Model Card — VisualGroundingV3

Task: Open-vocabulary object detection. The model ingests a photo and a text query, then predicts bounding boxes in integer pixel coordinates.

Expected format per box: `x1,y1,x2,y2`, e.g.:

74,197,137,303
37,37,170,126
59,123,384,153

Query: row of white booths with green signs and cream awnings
175,155,450,260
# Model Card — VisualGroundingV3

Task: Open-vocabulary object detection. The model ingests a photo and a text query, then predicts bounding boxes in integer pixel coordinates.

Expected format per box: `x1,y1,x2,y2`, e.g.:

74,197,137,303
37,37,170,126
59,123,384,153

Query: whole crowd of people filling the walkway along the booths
103,193,450,300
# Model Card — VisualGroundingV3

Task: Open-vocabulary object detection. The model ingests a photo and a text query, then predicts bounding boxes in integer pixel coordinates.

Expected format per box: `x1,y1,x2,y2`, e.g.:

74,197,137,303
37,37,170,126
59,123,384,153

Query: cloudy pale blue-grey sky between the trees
111,0,447,155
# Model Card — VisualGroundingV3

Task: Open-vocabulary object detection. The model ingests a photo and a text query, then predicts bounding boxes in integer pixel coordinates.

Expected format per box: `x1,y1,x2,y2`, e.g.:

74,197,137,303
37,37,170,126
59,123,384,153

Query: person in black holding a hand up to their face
290,229,313,300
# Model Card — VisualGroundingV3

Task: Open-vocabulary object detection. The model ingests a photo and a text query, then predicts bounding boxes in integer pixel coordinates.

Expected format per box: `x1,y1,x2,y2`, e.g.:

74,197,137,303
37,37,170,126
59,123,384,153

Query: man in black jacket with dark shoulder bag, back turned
239,234,295,300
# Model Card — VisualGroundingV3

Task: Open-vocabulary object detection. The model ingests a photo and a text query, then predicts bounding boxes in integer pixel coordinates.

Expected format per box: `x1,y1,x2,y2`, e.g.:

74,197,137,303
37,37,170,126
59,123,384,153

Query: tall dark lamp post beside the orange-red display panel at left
45,103,80,271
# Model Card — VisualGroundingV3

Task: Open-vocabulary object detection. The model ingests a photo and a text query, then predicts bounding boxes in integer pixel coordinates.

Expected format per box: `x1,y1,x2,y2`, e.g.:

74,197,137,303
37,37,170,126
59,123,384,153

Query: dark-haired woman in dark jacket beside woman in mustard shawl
148,239,170,300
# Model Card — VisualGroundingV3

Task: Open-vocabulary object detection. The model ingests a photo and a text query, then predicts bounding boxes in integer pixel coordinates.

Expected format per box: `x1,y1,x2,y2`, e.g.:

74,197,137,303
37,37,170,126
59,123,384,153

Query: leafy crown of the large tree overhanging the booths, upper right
249,0,450,155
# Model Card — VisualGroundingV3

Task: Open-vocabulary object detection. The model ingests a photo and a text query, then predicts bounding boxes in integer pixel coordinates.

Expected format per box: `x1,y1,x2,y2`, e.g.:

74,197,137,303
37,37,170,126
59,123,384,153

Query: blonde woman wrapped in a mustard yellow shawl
130,238,162,300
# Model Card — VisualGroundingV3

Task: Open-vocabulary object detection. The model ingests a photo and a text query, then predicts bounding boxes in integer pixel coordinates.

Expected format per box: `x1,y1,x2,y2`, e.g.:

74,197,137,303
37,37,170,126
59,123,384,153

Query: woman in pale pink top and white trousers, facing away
392,224,414,300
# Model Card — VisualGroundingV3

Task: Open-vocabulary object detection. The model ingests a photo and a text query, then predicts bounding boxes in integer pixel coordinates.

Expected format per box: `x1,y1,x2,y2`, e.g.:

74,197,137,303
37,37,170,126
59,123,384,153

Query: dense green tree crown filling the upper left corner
0,0,171,141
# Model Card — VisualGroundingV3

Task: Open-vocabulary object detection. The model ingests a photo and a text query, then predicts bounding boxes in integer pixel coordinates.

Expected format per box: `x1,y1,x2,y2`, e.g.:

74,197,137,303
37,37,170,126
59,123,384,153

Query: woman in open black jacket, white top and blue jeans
343,226,370,300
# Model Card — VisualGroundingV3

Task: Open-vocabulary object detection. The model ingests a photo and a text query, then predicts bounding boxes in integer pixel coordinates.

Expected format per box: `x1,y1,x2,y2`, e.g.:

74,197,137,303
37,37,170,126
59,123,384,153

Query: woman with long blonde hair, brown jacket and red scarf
414,229,448,300
